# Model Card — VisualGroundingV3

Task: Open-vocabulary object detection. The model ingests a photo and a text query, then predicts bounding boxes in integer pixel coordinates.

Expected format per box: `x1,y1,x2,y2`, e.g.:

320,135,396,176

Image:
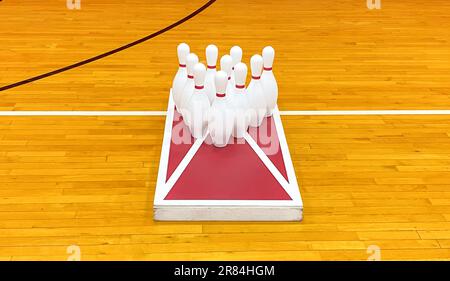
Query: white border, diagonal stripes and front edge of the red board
153,91,303,221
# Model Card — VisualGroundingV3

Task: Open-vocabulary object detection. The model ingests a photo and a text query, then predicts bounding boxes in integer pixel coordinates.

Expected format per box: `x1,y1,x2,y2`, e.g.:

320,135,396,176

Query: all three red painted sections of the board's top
165,109,291,200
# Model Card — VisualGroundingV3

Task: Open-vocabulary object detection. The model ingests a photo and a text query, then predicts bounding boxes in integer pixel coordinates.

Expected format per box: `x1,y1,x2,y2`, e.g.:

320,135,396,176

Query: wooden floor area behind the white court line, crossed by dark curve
0,0,450,110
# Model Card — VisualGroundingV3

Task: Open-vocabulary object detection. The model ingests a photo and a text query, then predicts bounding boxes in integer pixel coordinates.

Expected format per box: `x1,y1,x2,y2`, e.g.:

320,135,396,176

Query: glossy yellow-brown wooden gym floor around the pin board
0,0,450,260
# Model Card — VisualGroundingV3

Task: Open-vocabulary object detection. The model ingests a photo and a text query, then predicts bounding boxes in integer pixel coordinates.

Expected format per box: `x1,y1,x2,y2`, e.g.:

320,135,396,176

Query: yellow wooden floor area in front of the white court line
0,116,450,260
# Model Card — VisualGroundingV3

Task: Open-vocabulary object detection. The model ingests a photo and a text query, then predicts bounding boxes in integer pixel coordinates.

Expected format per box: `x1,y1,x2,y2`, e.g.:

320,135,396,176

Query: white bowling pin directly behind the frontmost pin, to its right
230,62,250,138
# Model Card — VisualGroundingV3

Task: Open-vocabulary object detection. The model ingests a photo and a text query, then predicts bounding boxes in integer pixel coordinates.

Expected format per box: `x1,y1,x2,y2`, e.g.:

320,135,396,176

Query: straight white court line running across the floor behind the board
0,110,450,116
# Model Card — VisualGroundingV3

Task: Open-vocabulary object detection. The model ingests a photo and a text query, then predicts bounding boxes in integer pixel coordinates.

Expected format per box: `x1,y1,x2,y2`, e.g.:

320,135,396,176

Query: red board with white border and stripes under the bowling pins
153,93,303,221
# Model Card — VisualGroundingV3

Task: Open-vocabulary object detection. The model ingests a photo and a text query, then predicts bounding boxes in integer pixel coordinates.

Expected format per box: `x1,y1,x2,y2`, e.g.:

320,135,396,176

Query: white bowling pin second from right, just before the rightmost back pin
247,55,267,127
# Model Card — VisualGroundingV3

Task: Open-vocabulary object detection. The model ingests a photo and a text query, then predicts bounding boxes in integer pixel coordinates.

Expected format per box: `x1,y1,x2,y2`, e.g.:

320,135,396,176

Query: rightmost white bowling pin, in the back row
261,46,278,116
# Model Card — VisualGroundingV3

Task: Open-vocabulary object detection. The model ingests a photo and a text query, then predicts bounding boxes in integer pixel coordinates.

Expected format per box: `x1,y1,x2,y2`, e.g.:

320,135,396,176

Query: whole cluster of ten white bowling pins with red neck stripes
172,43,278,147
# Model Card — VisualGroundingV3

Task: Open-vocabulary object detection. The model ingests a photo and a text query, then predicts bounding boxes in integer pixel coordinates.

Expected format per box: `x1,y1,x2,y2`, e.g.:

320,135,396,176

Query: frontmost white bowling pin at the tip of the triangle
208,71,234,147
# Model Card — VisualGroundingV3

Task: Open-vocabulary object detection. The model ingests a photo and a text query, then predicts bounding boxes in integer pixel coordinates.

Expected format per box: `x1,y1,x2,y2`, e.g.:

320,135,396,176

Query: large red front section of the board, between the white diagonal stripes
165,136,291,200
